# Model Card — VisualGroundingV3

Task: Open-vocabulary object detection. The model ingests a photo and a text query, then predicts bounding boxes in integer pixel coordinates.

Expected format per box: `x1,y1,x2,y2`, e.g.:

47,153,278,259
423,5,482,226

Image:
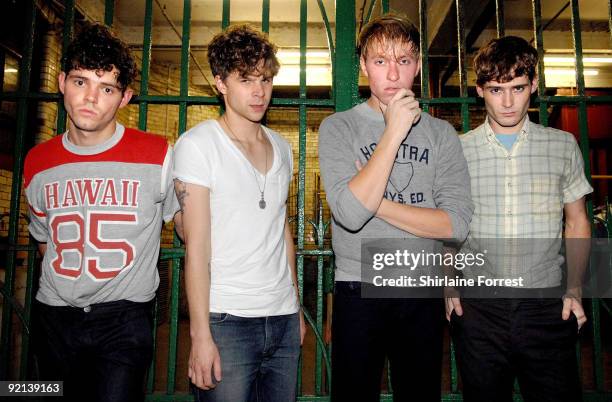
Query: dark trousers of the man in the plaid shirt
451,298,582,402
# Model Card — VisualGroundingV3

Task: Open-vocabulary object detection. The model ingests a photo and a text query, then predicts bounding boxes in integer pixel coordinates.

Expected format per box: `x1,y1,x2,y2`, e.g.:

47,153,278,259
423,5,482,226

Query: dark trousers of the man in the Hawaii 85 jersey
33,300,153,402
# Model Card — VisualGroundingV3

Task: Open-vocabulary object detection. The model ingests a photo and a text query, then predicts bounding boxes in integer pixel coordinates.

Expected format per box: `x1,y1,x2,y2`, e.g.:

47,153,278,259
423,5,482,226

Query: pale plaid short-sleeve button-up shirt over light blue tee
460,119,593,287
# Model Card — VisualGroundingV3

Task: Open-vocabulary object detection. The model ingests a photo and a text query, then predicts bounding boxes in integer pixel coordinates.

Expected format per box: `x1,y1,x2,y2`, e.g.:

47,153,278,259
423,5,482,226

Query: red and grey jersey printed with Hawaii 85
24,124,178,307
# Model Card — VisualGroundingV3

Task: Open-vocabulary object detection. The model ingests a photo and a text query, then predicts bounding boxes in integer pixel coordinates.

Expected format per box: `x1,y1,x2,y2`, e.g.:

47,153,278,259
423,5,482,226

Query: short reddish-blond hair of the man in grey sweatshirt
357,13,421,57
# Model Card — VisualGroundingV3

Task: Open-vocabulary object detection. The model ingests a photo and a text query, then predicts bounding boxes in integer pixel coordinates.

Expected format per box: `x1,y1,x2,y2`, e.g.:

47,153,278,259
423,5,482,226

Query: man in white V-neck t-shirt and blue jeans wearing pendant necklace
174,25,305,402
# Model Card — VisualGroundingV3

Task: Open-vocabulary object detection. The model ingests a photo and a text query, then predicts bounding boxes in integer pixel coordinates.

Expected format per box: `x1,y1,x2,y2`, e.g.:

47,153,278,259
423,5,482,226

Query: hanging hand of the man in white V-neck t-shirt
187,337,221,390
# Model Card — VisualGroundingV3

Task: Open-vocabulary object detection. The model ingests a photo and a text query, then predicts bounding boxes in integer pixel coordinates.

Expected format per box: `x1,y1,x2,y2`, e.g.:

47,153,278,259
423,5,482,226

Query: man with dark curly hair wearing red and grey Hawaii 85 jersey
24,25,178,402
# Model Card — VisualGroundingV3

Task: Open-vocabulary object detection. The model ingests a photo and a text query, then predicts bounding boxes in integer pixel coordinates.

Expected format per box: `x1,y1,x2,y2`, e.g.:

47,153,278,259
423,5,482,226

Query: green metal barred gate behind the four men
0,0,612,401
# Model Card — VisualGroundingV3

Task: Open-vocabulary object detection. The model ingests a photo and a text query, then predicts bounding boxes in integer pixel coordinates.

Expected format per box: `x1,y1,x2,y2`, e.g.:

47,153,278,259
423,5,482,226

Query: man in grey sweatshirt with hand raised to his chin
319,15,473,401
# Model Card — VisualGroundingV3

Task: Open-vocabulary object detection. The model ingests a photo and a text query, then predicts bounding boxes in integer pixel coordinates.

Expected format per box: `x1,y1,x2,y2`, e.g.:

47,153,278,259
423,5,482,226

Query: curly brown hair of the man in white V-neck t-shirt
208,24,280,80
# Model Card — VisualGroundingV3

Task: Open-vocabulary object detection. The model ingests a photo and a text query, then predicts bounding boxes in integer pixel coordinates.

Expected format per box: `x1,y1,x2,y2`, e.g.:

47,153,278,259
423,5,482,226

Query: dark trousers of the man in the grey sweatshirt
332,282,444,402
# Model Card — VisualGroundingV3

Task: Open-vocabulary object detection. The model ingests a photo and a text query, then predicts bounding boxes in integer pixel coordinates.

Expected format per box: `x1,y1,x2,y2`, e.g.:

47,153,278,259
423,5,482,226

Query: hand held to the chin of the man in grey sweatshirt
381,88,421,141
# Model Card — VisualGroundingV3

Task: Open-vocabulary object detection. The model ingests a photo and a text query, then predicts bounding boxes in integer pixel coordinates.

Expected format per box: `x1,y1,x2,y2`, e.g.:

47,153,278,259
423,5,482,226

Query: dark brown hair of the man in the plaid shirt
474,36,538,86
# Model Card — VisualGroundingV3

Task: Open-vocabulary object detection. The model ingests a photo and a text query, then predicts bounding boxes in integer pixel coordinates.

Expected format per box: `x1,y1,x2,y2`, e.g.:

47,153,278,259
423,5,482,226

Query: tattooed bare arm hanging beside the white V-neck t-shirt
175,179,221,389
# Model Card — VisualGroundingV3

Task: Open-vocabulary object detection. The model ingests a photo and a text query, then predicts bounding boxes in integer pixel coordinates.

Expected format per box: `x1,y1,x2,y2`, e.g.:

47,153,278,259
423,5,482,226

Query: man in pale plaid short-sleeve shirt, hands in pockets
446,36,593,402
